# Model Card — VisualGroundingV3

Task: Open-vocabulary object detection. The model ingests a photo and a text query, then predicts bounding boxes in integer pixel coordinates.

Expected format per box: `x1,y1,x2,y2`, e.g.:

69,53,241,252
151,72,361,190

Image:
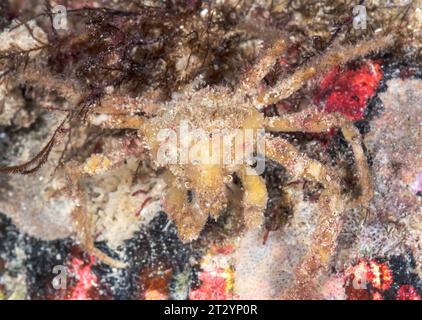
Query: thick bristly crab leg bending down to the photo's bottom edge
265,137,344,299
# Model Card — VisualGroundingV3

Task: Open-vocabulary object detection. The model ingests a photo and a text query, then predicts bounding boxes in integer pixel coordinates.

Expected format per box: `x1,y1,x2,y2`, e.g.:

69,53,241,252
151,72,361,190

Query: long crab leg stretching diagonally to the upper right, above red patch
258,35,394,105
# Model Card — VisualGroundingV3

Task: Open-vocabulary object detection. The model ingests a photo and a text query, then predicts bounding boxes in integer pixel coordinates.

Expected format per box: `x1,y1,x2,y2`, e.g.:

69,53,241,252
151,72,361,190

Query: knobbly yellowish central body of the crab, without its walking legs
141,87,267,241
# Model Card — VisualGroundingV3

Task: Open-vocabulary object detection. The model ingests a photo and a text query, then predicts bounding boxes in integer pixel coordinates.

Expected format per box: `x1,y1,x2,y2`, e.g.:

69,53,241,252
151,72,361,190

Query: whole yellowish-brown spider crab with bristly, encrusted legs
2,30,394,298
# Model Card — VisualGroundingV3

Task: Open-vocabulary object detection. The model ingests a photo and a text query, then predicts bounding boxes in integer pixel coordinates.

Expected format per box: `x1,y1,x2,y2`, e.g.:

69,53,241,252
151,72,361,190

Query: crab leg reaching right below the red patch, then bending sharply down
264,110,373,208
